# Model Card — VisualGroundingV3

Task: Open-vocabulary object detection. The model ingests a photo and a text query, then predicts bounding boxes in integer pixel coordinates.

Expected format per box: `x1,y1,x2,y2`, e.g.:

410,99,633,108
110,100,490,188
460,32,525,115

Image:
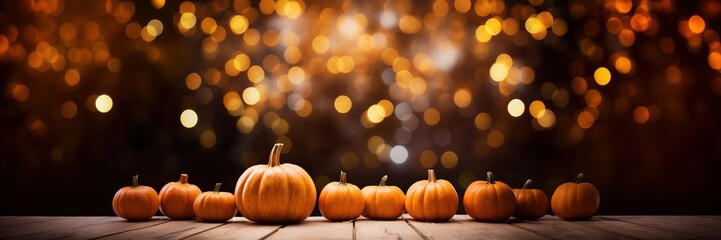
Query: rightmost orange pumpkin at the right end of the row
551,173,601,220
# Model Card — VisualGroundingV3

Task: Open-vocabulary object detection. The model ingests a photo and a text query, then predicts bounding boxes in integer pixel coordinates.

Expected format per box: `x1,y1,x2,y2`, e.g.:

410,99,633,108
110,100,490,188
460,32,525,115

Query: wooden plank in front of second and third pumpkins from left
101,220,224,239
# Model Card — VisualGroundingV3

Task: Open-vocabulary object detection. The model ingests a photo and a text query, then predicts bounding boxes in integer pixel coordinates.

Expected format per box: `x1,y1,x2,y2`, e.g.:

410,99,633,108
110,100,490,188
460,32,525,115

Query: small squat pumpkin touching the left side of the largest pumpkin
193,183,238,222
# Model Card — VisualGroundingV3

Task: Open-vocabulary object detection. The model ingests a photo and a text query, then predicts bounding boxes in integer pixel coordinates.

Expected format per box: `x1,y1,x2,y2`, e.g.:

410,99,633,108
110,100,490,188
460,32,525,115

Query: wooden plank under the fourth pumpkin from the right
403,214,547,239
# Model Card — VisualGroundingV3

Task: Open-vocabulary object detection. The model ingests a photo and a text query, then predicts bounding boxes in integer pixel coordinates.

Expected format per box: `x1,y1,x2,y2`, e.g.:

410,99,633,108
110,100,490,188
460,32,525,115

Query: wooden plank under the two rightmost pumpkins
512,215,631,239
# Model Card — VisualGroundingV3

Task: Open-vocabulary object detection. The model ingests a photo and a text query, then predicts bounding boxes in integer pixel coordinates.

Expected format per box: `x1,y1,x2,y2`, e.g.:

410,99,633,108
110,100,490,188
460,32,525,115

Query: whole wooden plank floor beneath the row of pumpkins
0,215,721,239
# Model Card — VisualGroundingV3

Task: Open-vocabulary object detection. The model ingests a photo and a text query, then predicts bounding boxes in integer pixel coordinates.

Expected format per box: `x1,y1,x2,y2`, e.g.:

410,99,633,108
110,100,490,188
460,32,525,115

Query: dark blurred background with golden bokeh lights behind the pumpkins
0,0,721,215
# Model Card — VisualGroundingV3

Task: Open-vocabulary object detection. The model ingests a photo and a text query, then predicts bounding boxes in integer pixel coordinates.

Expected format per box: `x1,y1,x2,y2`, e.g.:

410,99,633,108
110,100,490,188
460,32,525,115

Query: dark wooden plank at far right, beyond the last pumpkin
604,216,721,239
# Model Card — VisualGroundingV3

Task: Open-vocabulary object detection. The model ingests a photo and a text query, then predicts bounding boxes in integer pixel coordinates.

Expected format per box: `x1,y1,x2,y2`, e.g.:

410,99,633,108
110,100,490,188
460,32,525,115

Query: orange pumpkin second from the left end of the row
160,174,201,220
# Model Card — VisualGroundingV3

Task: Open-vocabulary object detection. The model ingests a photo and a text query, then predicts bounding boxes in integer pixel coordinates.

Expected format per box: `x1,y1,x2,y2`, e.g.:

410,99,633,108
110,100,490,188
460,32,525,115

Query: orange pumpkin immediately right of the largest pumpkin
318,171,365,222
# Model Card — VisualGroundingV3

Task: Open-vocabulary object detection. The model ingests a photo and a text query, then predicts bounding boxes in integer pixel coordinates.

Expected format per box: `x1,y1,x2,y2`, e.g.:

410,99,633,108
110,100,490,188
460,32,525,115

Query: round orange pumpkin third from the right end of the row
463,172,516,222
